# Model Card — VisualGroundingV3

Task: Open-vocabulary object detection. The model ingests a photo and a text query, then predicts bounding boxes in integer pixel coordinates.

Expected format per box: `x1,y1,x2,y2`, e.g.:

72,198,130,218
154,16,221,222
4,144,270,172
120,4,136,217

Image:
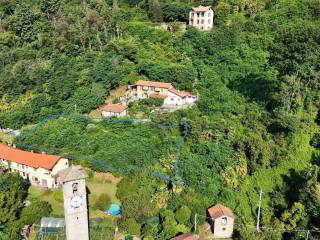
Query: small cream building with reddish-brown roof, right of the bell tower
208,204,234,238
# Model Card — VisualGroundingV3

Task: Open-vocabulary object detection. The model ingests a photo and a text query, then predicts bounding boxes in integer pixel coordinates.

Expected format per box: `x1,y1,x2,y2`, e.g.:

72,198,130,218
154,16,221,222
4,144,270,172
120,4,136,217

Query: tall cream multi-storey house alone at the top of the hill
189,5,214,31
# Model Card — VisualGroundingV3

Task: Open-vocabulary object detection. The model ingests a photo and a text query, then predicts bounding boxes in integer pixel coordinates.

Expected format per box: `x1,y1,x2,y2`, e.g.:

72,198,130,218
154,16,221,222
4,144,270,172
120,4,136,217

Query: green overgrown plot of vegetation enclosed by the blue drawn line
18,116,179,173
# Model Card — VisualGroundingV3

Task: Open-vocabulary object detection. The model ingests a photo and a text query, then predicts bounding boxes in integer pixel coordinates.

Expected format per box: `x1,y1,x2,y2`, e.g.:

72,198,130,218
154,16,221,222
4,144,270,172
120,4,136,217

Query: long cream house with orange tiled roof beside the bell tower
0,144,69,188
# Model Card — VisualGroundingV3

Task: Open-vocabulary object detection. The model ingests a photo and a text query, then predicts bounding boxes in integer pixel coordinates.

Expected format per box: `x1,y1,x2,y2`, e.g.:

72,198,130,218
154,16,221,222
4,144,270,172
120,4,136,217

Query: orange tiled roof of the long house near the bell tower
0,144,61,170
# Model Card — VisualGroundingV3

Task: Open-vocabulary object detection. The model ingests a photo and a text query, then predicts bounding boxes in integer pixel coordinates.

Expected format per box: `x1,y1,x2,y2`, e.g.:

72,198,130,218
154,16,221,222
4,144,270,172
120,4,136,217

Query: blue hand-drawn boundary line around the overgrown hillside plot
18,114,189,185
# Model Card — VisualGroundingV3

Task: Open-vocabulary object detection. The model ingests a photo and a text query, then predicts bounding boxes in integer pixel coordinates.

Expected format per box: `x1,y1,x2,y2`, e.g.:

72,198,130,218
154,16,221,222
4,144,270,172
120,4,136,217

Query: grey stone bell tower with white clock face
59,166,89,240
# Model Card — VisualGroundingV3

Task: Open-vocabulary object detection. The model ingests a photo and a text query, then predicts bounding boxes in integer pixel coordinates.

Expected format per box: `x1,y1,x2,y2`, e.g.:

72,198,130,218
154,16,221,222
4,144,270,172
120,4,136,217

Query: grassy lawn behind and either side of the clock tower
28,171,120,218
